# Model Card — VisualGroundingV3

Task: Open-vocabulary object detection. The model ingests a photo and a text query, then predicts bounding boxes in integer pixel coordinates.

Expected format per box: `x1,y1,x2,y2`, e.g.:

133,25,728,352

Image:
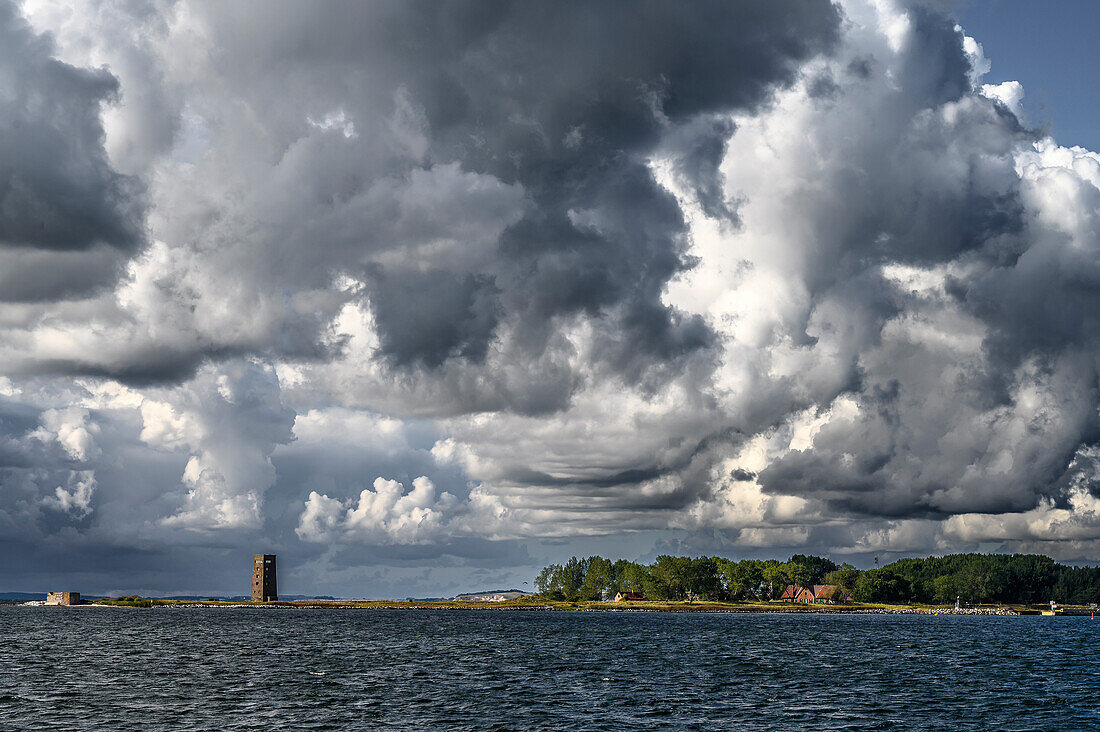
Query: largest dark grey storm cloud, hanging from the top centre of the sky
182,0,839,379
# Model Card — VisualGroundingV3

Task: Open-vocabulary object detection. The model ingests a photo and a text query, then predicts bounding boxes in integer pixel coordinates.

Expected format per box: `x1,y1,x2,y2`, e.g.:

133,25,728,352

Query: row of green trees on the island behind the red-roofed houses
535,554,1100,604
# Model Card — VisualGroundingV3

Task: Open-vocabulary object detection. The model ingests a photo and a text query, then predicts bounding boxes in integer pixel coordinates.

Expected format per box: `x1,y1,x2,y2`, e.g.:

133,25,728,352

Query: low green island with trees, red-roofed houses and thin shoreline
64,554,1100,615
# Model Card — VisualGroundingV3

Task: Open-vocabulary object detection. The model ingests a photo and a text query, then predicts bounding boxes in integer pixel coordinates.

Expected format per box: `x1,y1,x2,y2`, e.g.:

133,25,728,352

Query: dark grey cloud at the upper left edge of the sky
0,0,144,301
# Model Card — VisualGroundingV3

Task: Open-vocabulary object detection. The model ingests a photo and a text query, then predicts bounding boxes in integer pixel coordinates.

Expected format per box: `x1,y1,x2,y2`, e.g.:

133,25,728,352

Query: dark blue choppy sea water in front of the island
0,607,1100,730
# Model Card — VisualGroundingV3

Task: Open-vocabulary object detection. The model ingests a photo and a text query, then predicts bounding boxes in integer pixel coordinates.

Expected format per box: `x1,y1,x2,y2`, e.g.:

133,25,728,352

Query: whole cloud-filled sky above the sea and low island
0,0,1100,598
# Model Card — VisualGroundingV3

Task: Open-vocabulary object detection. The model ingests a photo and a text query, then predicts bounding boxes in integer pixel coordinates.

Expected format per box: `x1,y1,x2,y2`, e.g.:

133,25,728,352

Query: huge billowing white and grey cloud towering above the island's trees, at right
642,3,1096,550
